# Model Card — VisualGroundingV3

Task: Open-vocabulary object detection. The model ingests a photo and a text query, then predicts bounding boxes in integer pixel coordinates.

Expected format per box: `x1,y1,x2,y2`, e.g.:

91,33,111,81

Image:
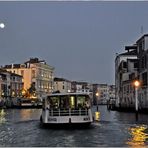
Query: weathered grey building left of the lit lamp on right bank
115,45,138,107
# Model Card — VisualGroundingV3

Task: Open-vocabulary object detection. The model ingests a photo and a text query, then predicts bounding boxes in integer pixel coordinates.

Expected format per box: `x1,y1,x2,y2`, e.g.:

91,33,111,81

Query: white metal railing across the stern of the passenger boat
49,108,88,116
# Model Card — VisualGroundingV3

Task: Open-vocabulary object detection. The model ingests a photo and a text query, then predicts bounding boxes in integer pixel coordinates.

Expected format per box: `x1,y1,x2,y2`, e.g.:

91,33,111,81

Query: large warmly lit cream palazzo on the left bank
3,58,54,98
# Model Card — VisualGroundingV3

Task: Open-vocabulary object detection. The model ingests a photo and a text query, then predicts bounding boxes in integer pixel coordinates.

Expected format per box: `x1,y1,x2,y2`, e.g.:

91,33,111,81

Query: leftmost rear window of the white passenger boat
49,96,60,109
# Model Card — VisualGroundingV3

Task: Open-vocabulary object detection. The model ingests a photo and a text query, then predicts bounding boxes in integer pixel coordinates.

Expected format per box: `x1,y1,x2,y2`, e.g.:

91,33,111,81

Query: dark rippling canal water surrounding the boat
0,105,148,147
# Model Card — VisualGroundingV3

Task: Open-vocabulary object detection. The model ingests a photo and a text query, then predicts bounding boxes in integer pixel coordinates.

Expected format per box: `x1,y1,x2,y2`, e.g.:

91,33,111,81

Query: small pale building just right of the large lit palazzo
54,77,71,93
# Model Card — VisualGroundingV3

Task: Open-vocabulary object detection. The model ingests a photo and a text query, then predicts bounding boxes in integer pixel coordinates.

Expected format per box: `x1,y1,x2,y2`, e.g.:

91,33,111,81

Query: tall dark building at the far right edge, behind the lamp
136,34,148,109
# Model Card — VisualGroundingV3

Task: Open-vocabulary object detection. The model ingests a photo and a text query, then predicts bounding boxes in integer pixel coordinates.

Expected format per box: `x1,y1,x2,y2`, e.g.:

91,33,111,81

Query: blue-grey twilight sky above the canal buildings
0,1,148,84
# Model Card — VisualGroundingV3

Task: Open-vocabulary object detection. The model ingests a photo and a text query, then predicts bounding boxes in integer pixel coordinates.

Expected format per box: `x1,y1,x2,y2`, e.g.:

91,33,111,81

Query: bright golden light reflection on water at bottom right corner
127,125,148,147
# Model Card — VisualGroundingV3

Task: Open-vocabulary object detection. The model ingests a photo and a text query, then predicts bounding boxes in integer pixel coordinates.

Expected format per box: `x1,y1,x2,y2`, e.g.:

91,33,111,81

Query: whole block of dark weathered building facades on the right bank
115,34,148,109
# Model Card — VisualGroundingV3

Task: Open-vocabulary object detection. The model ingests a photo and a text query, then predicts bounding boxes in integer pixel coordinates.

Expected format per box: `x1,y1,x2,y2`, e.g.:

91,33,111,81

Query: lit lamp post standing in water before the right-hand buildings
134,80,140,120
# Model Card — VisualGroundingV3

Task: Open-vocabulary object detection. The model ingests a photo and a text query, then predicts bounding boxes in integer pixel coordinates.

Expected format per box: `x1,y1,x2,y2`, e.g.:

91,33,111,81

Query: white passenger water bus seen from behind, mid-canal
40,93,93,126
